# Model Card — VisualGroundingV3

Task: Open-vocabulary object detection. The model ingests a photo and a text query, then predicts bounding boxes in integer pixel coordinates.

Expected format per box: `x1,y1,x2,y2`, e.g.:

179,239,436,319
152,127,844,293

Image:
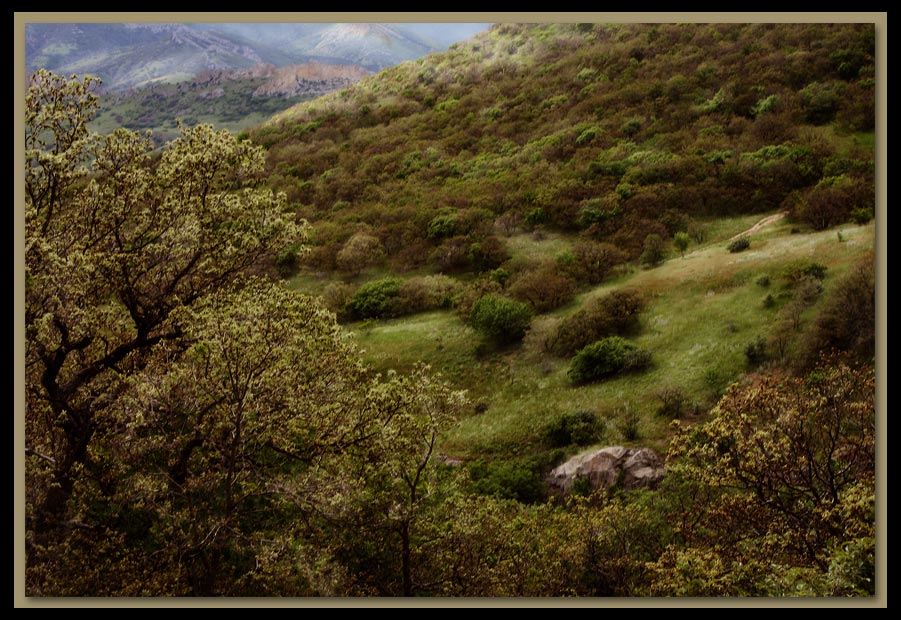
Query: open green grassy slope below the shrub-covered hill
292,215,875,470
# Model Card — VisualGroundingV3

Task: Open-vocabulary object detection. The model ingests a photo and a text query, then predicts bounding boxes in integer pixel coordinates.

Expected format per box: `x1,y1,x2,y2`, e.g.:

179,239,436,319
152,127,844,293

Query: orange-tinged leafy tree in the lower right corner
652,358,876,596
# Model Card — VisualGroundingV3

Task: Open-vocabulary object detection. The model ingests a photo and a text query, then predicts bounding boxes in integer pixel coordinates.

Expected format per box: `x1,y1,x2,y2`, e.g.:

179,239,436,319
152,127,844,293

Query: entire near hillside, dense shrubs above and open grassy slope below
255,24,874,480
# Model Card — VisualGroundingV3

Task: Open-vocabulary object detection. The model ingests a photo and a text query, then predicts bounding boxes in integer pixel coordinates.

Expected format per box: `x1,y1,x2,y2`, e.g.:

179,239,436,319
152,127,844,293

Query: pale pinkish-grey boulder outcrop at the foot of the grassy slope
547,446,665,493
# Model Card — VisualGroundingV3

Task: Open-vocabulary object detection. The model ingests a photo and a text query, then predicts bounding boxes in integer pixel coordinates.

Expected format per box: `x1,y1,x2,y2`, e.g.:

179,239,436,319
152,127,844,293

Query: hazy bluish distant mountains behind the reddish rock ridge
25,23,486,90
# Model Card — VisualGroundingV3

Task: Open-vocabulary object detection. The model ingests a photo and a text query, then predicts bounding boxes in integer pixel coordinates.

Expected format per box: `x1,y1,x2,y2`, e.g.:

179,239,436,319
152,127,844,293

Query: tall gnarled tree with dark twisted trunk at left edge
25,71,305,548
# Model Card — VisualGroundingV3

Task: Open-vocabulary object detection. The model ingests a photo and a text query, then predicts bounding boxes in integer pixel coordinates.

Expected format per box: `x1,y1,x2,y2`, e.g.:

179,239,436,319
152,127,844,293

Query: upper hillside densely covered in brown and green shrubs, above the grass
250,24,874,272
